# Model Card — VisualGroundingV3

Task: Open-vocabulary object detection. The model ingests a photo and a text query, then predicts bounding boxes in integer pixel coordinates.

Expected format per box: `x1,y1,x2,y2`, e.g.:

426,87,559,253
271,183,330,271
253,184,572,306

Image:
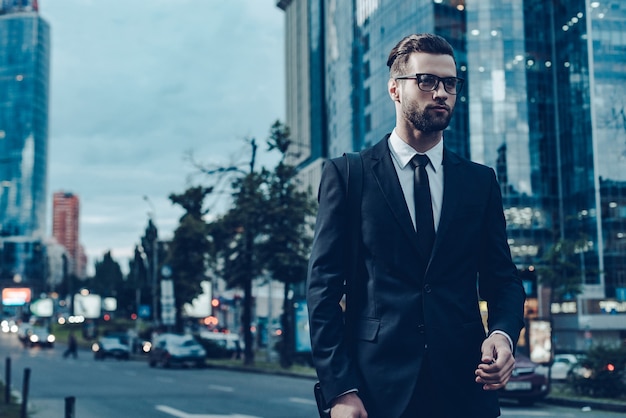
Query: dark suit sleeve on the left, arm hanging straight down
307,159,359,401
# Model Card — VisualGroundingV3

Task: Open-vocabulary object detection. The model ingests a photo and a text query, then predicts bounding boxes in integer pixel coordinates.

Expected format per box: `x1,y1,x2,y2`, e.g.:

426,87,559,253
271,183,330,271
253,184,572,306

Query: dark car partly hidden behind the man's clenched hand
499,354,550,405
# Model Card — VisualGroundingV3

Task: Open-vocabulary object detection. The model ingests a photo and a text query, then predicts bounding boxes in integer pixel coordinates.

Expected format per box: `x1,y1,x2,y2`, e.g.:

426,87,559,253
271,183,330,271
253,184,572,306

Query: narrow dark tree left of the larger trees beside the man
165,186,212,326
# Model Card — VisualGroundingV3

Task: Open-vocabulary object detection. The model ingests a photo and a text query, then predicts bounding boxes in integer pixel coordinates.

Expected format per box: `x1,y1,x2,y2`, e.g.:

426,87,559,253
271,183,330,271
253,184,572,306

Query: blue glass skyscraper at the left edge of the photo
0,0,50,294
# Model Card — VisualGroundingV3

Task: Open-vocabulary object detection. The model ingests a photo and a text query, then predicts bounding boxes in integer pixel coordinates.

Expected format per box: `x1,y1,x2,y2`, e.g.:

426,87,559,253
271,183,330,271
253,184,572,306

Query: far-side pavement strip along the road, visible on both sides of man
207,359,626,413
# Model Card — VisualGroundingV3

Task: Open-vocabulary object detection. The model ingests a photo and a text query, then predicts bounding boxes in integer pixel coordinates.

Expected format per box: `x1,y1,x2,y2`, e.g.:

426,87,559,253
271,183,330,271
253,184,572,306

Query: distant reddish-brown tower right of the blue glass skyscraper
52,192,85,278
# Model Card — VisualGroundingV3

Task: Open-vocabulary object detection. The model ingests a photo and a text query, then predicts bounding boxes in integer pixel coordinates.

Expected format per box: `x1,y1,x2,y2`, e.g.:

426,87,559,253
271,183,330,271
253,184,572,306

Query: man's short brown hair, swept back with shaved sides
387,33,456,76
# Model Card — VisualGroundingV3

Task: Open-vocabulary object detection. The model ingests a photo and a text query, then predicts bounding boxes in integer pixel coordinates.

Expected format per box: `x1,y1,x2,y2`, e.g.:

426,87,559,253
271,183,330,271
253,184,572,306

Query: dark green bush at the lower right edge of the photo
569,346,626,398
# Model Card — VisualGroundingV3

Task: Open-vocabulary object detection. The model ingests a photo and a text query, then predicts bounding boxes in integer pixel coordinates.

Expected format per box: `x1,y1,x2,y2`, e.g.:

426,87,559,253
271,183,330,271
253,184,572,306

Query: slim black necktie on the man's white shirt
411,154,435,258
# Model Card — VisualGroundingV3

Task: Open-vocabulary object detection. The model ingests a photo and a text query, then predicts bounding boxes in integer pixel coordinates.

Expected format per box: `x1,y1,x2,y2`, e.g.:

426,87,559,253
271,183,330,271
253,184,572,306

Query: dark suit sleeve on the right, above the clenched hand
479,170,526,348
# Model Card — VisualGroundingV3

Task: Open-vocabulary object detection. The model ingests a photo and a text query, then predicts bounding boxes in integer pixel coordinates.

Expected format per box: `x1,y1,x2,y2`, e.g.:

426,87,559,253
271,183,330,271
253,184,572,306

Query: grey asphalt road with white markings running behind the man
0,334,623,418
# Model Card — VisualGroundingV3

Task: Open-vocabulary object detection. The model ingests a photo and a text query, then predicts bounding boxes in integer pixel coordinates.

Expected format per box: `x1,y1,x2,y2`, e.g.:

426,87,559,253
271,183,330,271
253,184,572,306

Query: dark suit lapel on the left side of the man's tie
371,139,418,250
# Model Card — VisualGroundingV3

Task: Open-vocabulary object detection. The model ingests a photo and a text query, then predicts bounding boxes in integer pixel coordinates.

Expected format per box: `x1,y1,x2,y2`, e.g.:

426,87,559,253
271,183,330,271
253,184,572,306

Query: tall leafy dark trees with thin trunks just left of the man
209,121,315,367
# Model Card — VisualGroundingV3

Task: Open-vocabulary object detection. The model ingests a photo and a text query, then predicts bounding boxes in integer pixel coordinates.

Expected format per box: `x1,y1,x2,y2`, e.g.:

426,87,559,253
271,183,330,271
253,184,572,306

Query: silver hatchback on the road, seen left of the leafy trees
148,333,206,368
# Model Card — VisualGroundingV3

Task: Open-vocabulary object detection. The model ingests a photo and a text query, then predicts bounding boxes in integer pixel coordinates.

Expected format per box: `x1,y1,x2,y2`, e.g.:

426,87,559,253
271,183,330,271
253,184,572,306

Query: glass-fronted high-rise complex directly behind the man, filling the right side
277,0,626,349
